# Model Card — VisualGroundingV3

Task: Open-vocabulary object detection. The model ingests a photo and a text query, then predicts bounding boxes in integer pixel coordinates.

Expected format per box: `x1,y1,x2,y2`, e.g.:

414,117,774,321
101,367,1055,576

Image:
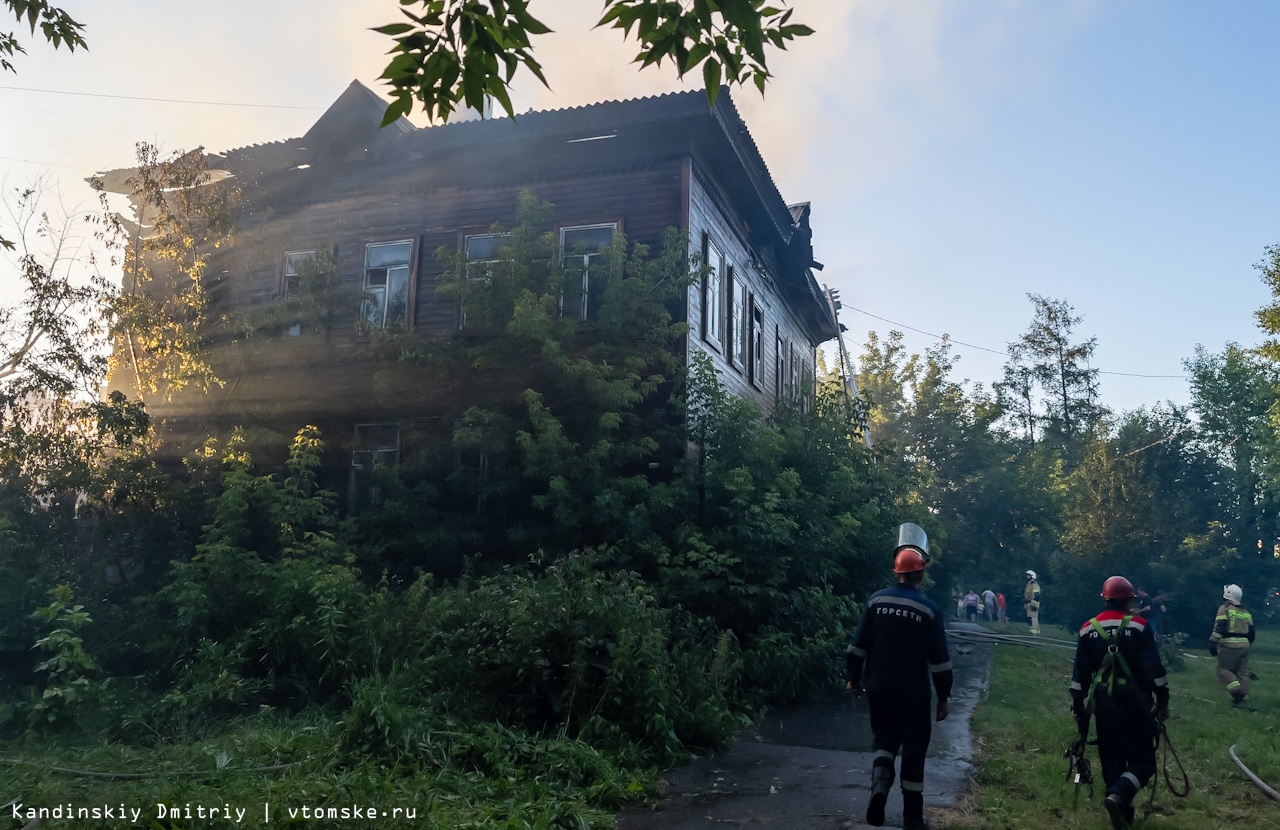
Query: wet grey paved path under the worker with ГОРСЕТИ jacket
618,623,991,830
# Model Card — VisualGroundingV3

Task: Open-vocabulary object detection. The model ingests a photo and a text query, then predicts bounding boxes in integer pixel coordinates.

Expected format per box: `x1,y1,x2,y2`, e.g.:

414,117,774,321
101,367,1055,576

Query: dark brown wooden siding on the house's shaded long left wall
140,159,682,428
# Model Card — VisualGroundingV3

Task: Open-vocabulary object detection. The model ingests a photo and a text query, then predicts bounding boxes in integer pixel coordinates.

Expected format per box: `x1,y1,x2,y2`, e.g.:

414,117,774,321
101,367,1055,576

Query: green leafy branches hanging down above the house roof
375,0,813,126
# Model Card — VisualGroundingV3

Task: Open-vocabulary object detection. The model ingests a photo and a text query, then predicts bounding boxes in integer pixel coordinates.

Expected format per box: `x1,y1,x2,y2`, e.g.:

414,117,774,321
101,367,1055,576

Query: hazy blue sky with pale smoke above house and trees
0,0,1280,410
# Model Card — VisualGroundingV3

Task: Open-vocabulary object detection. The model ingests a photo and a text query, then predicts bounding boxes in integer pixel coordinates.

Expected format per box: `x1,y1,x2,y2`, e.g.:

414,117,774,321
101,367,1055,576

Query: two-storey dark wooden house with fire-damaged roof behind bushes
104,82,837,502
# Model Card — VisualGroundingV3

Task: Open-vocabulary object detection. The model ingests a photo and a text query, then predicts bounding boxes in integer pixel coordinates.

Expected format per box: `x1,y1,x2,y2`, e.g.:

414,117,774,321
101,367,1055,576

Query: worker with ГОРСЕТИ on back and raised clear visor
845,523,954,830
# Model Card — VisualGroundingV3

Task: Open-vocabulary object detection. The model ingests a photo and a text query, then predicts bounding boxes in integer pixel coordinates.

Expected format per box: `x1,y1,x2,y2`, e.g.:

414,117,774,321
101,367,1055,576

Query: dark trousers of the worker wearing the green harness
1093,689,1156,803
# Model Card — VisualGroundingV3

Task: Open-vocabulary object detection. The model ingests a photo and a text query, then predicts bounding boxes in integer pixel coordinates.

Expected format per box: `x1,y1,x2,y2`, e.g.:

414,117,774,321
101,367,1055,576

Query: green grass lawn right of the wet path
952,626,1280,830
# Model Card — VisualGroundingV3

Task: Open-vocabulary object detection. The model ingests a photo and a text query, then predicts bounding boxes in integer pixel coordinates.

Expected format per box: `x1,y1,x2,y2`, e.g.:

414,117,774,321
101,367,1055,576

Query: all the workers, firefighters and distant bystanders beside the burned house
845,524,1254,830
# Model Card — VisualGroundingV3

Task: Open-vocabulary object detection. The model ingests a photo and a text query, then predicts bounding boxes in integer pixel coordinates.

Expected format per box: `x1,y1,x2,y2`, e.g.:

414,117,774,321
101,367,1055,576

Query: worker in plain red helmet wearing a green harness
1071,576,1169,830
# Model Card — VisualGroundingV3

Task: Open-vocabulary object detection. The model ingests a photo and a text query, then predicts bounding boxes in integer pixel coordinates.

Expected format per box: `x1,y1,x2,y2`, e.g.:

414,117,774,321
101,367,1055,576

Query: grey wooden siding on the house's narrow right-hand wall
689,163,818,411
